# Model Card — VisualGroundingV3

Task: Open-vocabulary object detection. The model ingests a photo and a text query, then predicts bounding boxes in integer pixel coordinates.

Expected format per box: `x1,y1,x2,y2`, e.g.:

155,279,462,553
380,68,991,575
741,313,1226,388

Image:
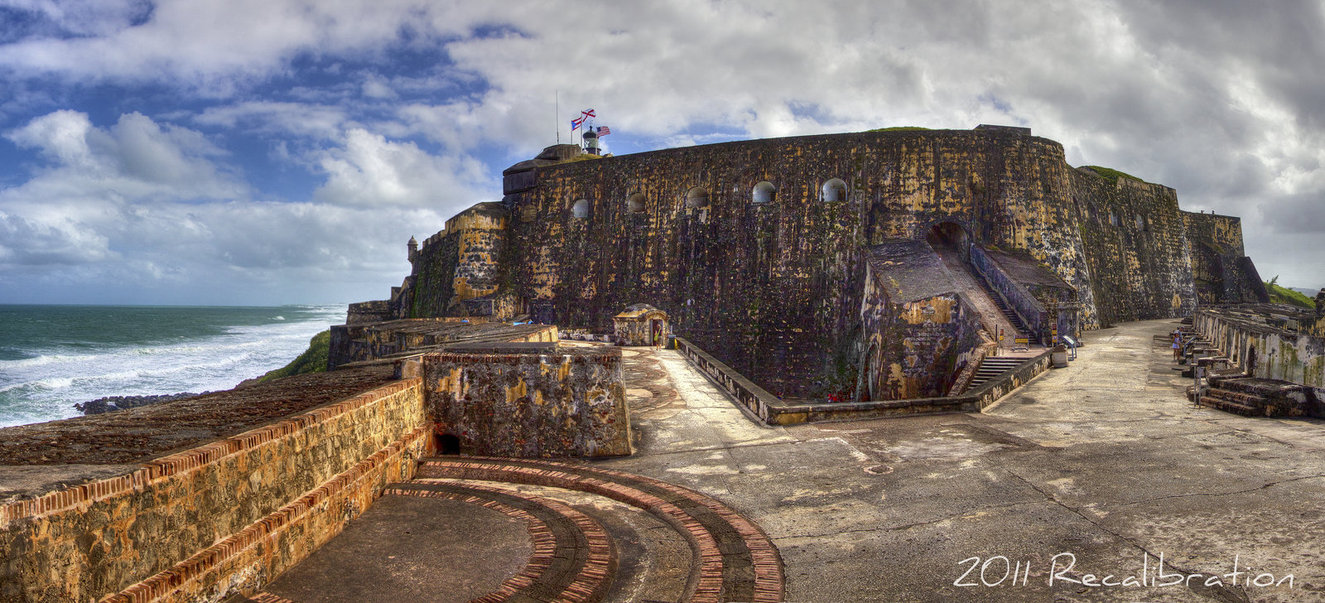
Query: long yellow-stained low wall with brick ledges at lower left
0,379,432,602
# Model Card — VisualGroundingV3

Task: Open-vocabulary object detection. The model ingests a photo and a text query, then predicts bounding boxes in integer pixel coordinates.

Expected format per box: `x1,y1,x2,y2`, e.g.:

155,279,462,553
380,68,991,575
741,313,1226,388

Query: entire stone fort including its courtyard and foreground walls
0,126,1325,603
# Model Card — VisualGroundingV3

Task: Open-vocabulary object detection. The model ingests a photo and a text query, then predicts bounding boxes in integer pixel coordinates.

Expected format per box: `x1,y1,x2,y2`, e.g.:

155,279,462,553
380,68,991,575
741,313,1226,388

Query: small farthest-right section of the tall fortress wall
1182,212,1269,305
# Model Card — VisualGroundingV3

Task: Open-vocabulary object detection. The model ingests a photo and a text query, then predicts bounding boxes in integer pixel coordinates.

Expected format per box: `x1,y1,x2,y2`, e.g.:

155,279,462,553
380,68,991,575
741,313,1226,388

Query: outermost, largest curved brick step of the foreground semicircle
416,457,783,602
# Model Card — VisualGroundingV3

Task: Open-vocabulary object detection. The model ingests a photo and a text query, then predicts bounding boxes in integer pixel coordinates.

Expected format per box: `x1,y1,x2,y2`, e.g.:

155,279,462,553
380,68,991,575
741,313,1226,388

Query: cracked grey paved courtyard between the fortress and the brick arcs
602,321,1325,602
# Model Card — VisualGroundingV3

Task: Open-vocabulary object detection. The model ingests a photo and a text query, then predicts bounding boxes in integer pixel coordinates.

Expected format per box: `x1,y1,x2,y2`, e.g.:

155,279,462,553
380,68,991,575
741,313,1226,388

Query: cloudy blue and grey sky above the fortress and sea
0,0,1325,305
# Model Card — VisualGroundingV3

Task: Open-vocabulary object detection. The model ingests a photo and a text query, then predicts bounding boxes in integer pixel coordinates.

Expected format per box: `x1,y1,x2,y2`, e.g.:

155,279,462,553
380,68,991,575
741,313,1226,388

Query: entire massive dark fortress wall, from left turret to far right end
371,126,1259,396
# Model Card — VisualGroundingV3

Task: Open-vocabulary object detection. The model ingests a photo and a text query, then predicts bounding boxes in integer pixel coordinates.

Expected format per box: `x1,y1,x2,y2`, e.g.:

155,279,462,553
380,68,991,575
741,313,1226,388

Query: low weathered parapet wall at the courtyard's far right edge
1194,307,1325,390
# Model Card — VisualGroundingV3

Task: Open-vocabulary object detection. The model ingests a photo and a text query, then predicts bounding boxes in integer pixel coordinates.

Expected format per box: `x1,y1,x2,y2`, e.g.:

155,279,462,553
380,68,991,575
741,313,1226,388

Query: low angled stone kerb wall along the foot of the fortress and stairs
676,337,1049,425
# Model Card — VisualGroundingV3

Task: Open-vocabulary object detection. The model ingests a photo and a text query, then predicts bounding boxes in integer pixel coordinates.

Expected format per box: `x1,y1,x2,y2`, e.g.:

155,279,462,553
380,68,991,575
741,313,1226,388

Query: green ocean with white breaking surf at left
0,305,346,427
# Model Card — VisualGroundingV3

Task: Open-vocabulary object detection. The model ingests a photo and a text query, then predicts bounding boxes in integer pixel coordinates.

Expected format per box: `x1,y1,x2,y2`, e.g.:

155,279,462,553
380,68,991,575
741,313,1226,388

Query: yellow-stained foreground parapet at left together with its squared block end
0,347,632,602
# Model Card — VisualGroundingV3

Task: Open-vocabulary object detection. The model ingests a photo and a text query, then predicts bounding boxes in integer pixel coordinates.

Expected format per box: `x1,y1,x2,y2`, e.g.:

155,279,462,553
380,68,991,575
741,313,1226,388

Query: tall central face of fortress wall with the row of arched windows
506,131,1089,395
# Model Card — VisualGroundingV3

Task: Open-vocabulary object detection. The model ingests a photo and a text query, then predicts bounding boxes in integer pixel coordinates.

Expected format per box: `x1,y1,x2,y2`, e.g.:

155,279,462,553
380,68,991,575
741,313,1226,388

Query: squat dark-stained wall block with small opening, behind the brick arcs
423,349,631,459
